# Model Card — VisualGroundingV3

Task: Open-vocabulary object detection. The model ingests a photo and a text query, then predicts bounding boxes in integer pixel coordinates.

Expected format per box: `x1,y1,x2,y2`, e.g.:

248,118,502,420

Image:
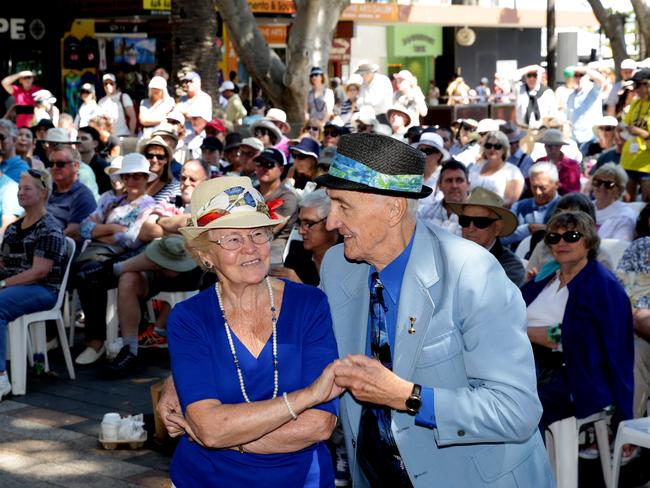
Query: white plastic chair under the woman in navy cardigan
546,412,611,488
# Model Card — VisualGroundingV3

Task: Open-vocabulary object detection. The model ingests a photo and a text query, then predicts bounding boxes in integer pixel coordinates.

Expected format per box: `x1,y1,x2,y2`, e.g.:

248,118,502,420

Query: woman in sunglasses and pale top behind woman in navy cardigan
591,163,637,242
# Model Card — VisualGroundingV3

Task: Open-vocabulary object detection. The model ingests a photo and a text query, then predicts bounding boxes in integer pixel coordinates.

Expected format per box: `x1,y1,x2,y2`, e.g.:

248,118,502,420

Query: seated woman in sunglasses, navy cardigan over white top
521,211,634,434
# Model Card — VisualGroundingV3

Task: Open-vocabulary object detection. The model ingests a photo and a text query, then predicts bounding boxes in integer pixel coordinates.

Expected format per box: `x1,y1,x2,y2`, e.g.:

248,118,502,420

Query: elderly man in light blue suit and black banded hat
317,134,555,488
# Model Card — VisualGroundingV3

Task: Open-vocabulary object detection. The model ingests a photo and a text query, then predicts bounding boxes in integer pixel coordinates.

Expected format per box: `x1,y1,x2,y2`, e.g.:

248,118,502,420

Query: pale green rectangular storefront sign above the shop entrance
388,25,442,57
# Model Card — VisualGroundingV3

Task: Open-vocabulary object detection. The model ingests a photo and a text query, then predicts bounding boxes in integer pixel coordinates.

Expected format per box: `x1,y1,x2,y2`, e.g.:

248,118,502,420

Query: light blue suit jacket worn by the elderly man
321,221,555,488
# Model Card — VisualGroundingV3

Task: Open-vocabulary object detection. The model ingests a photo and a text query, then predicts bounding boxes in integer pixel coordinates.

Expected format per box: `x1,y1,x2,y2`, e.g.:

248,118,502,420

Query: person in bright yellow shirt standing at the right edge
621,68,650,202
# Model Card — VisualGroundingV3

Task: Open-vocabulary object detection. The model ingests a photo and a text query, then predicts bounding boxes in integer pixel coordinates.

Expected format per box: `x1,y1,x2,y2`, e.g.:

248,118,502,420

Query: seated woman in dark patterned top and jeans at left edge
0,169,68,400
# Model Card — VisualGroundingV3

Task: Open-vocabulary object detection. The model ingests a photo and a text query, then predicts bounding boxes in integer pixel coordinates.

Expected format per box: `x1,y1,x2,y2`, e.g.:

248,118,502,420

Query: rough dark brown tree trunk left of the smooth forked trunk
171,0,219,115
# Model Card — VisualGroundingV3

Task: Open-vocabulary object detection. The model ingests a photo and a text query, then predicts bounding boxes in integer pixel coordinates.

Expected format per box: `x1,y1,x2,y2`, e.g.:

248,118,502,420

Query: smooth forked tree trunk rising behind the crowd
214,0,350,132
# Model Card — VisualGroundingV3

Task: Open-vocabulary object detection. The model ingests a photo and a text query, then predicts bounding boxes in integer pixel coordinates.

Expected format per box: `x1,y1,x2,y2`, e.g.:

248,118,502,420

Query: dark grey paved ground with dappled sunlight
0,350,650,488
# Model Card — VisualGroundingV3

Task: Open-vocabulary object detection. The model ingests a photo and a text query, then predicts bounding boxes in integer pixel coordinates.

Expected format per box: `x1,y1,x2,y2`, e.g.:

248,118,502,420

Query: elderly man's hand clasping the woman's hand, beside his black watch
334,354,413,410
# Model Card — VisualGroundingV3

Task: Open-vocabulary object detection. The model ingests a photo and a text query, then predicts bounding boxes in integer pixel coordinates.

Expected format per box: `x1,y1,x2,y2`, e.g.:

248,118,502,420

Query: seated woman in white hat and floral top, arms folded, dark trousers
73,153,156,364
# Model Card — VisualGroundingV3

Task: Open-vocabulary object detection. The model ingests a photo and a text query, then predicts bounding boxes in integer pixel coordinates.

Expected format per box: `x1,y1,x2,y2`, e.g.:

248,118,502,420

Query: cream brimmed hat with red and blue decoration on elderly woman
179,176,287,240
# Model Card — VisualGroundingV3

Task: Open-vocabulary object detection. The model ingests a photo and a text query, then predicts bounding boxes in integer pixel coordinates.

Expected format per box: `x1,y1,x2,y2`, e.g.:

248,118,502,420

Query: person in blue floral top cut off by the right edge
616,204,650,418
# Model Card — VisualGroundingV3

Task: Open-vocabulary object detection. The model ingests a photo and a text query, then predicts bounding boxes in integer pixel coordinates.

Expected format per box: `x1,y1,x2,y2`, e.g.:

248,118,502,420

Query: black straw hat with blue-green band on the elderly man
315,133,433,198
